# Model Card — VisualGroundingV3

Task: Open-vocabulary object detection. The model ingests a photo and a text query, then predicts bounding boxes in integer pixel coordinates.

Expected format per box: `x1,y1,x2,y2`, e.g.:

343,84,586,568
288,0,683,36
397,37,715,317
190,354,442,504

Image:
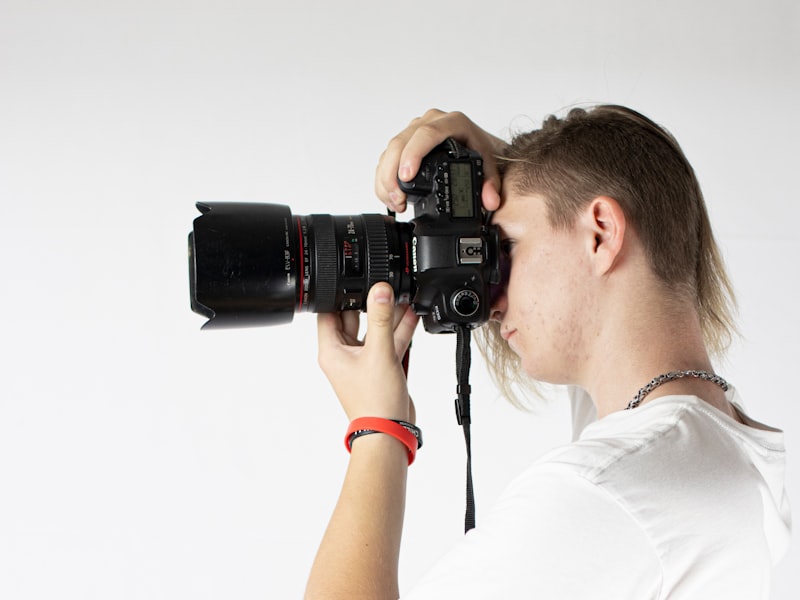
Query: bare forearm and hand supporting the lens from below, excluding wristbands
306,283,418,600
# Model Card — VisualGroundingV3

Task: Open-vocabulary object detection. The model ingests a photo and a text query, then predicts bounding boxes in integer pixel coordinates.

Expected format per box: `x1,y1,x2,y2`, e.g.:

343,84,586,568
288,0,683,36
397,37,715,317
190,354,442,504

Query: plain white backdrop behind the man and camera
0,0,800,600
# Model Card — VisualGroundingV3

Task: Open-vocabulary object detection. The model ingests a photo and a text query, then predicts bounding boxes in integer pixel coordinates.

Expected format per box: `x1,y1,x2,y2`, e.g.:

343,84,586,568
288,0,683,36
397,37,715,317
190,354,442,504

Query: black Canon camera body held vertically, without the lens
399,139,500,333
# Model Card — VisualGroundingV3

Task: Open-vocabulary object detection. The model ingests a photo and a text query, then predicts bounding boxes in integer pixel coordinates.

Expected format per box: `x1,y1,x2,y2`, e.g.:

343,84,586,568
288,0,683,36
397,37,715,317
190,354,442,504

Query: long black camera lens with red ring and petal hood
189,202,414,328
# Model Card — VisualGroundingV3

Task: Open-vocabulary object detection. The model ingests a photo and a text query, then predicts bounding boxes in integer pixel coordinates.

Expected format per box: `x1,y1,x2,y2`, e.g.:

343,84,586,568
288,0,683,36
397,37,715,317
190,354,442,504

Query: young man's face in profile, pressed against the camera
492,186,592,383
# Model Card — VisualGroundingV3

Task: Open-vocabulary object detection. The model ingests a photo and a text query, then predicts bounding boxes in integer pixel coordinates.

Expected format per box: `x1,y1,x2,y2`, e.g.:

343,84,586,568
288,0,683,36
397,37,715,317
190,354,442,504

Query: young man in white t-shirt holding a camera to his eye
307,106,789,599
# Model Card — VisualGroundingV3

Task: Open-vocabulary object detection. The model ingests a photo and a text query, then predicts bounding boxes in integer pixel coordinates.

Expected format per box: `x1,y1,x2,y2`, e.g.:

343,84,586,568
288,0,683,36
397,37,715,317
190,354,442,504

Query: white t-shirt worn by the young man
403,389,790,600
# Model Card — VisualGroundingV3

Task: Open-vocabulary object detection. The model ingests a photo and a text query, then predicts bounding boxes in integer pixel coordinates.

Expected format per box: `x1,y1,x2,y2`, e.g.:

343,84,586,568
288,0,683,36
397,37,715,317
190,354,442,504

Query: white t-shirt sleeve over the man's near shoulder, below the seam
402,466,662,600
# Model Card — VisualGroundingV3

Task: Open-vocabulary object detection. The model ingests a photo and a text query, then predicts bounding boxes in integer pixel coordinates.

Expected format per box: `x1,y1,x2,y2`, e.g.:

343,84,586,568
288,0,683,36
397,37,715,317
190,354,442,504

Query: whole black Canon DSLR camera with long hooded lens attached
189,139,501,333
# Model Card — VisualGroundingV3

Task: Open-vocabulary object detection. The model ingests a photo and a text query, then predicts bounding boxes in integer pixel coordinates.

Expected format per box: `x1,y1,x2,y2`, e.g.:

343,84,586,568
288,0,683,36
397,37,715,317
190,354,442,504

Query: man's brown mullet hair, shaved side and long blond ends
481,105,736,403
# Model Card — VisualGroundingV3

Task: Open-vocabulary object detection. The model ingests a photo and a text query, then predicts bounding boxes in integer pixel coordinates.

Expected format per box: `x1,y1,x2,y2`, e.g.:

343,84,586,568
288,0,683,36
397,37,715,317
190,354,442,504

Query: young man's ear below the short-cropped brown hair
581,196,627,275
